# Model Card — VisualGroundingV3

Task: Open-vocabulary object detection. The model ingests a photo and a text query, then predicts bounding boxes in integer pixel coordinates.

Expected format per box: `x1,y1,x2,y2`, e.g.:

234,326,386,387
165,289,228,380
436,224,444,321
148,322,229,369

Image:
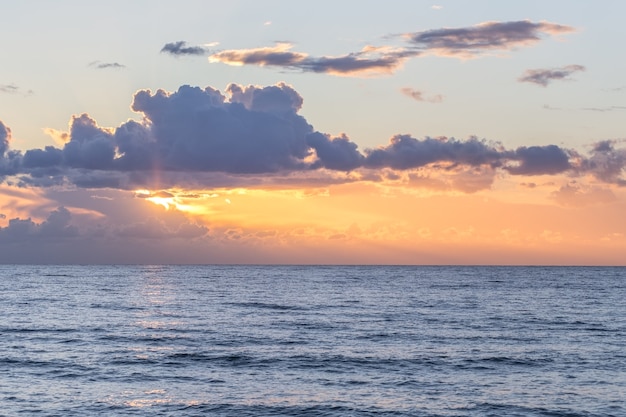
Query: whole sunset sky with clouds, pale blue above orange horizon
0,0,626,265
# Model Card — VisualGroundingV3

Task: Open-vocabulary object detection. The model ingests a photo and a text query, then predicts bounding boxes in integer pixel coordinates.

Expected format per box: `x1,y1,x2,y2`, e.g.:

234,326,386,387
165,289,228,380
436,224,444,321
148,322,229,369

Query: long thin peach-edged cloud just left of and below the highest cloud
209,42,417,75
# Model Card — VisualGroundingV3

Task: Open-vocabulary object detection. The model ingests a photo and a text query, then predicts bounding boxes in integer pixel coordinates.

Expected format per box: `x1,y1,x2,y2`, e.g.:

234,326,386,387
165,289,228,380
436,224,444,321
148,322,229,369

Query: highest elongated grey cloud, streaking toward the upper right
404,20,574,58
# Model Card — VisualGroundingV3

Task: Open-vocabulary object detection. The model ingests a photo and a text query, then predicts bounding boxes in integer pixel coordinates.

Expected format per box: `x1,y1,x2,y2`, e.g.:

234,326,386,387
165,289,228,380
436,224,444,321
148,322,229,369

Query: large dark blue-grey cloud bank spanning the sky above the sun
0,83,626,189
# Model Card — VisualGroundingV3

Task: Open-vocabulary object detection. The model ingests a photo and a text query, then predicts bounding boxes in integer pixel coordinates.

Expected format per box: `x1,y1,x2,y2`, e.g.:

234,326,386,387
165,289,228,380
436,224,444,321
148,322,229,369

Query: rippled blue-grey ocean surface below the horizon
0,265,626,417
